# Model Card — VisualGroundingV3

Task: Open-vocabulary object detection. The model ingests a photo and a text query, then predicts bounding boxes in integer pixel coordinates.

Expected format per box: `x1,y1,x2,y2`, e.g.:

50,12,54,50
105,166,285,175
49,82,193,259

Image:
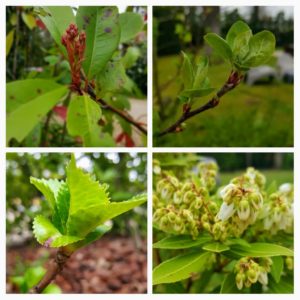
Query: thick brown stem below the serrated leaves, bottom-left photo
29,248,71,294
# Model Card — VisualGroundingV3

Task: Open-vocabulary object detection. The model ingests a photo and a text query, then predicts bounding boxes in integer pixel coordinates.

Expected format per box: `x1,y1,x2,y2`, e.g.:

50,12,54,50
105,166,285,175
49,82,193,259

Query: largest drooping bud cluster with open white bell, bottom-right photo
217,168,265,236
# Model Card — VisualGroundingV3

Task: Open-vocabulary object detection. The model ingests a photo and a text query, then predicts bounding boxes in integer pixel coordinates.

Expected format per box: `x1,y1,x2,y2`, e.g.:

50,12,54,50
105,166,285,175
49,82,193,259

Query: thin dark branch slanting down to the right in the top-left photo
87,84,147,135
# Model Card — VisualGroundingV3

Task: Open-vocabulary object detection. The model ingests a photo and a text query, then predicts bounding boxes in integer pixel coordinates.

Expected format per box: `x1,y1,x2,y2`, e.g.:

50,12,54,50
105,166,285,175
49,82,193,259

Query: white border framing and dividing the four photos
0,0,300,300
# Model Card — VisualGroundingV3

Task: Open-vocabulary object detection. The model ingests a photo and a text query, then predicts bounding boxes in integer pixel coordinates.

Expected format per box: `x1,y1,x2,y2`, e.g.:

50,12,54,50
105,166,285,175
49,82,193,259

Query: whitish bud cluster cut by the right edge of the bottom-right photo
263,183,294,234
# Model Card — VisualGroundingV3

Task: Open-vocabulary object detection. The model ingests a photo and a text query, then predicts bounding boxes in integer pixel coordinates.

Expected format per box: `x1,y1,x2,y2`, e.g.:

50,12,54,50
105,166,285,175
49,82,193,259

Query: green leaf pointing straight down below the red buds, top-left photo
67,94,102,147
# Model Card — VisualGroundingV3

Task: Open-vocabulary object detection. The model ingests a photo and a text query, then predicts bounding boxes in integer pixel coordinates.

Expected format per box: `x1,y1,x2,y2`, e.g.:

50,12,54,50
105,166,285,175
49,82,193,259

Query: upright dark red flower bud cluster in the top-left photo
61,24,86,94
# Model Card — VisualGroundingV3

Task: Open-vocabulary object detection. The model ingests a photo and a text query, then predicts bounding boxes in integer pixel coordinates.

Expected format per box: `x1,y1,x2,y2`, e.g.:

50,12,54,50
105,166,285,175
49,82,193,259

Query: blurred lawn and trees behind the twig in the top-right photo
153,6,294,147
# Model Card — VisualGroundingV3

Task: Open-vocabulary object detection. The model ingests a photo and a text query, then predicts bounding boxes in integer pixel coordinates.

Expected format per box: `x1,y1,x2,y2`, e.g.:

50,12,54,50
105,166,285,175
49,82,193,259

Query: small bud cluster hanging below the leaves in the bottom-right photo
234,257,272,290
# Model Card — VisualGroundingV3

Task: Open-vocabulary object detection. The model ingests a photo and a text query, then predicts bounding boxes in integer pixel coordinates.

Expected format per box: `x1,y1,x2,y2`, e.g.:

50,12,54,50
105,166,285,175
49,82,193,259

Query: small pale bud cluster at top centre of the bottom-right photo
198,161,219,191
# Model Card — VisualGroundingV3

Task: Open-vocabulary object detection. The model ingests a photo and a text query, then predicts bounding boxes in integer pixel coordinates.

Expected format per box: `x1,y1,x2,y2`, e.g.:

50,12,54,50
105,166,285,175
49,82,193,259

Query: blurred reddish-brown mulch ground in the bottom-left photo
6,237,147,293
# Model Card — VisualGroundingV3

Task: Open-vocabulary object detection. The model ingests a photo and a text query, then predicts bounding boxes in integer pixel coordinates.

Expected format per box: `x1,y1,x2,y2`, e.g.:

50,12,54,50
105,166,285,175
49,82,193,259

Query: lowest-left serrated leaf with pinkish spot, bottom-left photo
33,215,82,248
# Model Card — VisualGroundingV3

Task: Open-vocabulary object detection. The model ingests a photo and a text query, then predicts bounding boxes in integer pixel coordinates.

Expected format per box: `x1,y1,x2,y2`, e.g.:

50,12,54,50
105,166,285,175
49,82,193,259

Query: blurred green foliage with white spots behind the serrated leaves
6,153,147,246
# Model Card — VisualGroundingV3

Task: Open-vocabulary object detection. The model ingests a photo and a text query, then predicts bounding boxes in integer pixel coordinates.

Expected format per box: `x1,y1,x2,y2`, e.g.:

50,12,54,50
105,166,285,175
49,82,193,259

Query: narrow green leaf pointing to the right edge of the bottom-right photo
230,243,294,257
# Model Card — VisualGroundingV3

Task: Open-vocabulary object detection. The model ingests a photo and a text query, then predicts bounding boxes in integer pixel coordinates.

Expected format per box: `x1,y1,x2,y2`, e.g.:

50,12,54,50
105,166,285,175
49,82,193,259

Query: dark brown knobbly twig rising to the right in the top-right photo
157,71,243,137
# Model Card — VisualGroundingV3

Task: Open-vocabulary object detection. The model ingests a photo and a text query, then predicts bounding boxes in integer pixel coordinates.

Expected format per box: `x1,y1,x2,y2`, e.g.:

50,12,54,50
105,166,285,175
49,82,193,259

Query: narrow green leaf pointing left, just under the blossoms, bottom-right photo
153,235,212,249
